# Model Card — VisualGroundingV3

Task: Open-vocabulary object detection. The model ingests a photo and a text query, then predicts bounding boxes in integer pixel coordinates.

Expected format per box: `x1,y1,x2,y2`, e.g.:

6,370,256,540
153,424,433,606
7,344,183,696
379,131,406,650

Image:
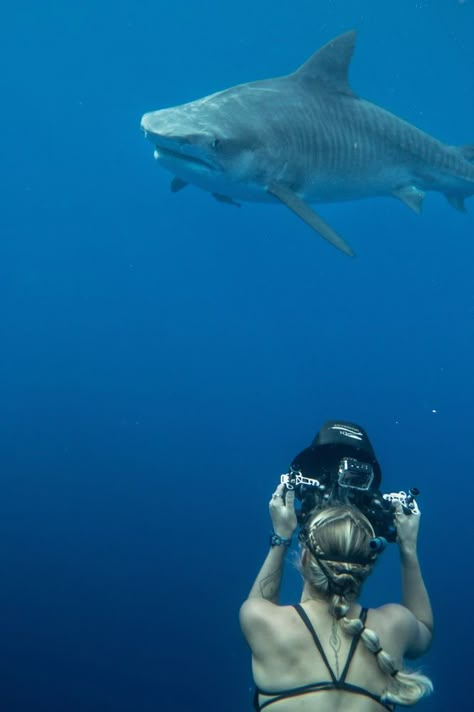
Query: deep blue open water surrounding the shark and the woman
0,0,474,712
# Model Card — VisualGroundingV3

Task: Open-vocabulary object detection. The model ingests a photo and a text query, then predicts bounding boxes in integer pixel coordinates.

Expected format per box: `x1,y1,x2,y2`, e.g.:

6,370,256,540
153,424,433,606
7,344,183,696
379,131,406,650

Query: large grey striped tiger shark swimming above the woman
141,31,474,255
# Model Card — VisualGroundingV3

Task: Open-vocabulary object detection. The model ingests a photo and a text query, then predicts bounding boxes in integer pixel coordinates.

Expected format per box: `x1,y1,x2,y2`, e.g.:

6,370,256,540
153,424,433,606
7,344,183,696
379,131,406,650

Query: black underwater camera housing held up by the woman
280,420,419,550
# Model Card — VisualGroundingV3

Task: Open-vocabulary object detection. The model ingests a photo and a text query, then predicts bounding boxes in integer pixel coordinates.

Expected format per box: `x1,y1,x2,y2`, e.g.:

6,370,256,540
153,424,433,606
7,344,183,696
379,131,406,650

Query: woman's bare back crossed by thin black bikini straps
246,600,410,712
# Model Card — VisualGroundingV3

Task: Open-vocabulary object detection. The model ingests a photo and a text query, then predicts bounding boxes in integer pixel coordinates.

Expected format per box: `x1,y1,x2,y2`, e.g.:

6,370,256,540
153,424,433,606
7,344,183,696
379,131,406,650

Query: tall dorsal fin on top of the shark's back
292,30,356,96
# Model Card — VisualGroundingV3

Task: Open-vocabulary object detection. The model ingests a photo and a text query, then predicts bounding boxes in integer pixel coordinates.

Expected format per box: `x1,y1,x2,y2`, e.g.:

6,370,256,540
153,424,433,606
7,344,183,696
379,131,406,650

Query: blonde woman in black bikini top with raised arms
240,420,433,712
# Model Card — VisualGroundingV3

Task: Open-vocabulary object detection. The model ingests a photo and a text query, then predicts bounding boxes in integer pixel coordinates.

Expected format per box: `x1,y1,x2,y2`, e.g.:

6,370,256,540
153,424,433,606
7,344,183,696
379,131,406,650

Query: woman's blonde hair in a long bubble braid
300,505,433,705
